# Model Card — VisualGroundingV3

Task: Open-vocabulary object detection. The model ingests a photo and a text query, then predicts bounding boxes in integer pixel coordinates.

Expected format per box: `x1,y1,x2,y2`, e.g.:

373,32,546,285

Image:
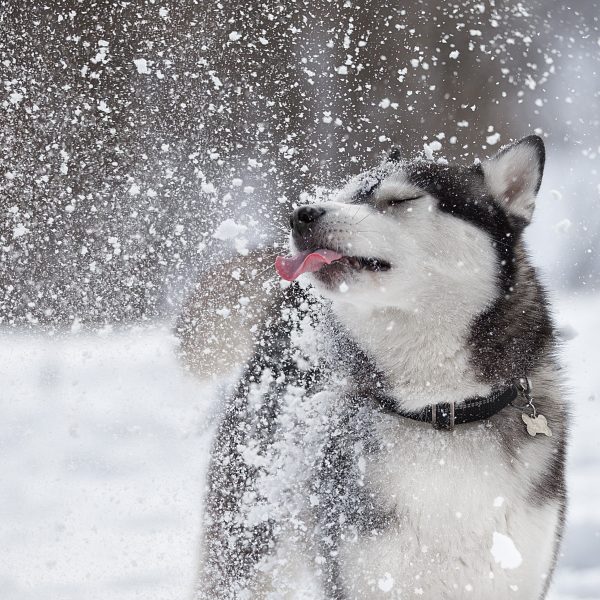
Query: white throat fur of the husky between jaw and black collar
333,303,491,410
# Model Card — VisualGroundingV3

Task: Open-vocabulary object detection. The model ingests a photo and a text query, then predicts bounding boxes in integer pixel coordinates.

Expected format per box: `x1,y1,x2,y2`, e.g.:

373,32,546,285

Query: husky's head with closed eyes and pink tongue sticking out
277,136,544,310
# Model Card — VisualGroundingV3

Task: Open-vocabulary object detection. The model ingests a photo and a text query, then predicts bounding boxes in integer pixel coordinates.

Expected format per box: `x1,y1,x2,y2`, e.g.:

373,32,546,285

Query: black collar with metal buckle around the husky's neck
377,383,521,429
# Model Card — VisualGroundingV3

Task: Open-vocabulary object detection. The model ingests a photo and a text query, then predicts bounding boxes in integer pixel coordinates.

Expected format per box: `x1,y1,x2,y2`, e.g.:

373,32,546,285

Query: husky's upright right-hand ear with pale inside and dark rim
482,135,546,224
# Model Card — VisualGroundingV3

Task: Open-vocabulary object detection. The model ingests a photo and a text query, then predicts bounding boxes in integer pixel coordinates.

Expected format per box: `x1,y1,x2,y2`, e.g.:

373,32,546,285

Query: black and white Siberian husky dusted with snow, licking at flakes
196,136,568,600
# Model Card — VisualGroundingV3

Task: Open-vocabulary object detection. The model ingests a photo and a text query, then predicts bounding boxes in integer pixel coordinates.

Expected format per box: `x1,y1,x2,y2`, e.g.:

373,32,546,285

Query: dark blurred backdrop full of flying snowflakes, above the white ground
0,0,600,327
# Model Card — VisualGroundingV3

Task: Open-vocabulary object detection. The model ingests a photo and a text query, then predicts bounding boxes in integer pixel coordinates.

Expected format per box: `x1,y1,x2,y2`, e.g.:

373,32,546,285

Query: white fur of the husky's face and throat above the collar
294,174,497,410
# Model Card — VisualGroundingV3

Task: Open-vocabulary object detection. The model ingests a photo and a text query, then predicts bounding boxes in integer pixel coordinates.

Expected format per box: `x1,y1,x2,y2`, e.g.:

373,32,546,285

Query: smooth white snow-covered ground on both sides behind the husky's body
0,297,600,600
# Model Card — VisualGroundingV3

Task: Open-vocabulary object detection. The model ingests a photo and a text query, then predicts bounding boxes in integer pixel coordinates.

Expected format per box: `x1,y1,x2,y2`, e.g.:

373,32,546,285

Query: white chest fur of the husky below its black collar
341,415,558,599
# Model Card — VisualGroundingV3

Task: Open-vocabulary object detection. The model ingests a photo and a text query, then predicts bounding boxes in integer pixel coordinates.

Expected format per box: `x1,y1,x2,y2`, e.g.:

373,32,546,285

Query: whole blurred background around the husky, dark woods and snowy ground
0,0,600,600
